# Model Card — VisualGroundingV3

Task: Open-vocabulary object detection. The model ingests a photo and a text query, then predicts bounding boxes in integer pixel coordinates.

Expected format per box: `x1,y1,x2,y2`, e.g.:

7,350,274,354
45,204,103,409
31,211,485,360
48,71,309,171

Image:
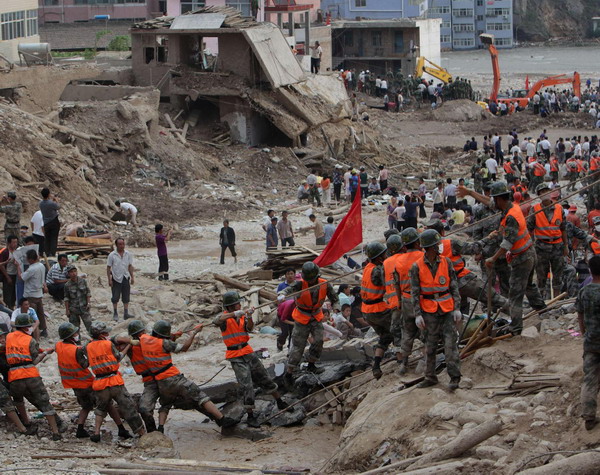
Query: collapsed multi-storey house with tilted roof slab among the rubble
131,7,350,146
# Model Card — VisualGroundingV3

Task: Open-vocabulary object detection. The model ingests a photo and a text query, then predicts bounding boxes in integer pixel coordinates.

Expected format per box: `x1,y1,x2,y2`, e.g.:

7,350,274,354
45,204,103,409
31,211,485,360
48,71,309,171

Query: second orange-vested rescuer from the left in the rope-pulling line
55,322,132,439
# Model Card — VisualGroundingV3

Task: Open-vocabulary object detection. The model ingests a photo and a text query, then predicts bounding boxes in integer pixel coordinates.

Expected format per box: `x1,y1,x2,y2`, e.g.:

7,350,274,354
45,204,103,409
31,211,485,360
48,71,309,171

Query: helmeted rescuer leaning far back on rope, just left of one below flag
218,291,289,427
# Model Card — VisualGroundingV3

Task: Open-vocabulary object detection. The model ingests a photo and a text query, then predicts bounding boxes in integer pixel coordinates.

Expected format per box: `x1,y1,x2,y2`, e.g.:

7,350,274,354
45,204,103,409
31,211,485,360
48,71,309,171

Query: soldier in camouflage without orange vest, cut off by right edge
575,256,600,430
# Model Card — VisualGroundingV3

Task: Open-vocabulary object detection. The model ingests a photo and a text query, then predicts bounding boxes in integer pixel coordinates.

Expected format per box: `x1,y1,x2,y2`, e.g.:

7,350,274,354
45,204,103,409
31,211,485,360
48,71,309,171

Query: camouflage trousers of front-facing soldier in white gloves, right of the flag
423,312,461,382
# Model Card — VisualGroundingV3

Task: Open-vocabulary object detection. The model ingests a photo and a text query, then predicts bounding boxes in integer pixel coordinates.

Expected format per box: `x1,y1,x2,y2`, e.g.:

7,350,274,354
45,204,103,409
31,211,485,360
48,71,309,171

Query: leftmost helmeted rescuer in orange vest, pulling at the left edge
6,313,62,440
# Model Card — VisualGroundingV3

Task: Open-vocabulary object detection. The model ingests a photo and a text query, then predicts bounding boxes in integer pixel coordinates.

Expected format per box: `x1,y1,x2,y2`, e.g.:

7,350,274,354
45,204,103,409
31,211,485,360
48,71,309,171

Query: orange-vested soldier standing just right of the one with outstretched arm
527,183,569,297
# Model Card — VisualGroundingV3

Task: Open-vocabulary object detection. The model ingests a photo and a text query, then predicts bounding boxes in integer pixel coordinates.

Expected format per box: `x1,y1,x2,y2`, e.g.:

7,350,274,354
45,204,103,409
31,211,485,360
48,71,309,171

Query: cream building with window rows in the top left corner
0,0,40,62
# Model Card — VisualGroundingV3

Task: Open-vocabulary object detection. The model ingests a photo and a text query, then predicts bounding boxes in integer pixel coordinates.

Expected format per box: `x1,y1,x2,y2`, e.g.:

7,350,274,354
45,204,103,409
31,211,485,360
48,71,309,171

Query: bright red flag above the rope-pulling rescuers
313,186,362,267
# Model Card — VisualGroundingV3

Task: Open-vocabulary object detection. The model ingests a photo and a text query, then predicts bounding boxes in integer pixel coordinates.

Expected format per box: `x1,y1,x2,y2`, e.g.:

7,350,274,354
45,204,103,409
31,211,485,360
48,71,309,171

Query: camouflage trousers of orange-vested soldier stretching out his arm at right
508,250,546,333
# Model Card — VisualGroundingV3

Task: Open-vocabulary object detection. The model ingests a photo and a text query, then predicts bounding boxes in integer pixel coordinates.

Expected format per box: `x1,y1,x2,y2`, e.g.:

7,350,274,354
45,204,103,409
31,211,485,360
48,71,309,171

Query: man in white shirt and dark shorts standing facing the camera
106,238,134,322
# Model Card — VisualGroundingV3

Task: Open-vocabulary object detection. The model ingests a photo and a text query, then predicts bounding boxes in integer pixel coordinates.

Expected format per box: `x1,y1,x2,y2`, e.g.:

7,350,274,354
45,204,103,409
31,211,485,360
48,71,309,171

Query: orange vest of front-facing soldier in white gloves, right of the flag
417,255,454,313
